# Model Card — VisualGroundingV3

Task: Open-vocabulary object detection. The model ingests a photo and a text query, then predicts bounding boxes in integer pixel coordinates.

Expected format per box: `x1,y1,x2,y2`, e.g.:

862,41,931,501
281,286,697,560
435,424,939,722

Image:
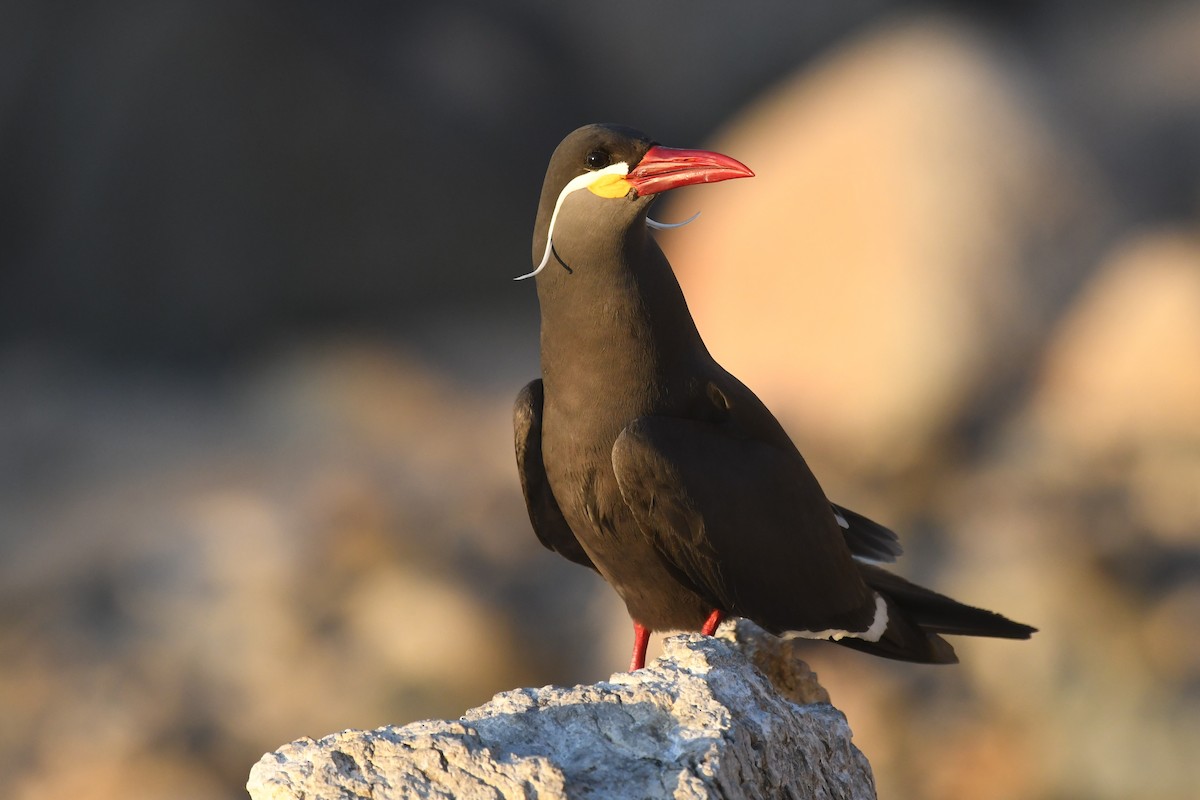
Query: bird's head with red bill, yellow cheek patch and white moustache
517,125,754,279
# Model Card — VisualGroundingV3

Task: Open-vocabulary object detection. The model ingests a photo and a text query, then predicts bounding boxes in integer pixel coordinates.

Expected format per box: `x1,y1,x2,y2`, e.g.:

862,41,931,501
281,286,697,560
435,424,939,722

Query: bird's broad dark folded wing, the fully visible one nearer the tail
612,416,876,633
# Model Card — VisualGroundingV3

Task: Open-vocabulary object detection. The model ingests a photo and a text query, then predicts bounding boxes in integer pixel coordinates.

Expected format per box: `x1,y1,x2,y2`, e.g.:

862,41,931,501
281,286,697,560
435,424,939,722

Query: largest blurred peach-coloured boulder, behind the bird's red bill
662,18,1105,471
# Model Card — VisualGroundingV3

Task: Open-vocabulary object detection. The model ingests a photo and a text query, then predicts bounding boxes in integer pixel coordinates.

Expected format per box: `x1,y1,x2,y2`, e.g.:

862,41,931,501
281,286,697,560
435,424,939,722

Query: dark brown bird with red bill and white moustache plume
514,124,1036,670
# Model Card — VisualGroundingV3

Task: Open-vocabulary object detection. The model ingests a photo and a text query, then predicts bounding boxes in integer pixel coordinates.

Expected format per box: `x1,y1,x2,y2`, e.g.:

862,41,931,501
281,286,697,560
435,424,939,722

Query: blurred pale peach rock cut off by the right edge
1016,228,1200,552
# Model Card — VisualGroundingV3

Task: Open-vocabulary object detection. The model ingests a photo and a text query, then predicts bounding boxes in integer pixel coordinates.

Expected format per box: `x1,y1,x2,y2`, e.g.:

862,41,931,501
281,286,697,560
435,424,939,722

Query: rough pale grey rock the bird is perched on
247,626,875,800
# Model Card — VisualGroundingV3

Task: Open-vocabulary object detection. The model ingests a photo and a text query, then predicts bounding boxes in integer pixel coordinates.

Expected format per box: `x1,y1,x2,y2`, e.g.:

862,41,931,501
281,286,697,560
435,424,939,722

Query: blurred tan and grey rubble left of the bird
0,342,601,800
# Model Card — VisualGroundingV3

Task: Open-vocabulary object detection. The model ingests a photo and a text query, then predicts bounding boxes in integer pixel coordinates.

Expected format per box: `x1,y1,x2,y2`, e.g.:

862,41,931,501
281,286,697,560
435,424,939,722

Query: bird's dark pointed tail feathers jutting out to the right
839,564,1037,663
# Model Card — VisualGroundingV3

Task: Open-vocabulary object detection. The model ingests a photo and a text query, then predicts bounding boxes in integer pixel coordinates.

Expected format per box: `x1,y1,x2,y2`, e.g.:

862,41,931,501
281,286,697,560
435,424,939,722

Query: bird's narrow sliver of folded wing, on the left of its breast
512,379,595,570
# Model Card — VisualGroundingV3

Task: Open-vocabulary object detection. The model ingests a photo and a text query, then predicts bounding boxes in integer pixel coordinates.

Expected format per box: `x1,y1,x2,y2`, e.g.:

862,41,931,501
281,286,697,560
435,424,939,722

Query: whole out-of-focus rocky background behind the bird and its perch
0,0,1200,800
